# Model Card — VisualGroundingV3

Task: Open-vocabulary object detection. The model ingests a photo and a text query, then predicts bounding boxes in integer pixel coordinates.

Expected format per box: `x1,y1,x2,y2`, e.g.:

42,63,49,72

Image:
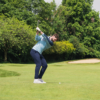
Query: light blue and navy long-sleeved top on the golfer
32,33,53,54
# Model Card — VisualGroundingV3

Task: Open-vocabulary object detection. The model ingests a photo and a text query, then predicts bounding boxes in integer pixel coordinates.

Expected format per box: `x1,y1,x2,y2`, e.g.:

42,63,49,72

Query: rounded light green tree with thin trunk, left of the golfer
0,16,34,62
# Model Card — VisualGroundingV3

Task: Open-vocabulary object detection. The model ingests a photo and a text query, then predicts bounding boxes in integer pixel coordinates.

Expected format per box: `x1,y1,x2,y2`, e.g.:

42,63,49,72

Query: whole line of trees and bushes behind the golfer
0,0,100,62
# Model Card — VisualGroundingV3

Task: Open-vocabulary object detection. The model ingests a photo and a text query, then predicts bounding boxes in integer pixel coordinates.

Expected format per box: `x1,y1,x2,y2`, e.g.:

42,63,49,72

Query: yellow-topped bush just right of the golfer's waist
44,41,75,60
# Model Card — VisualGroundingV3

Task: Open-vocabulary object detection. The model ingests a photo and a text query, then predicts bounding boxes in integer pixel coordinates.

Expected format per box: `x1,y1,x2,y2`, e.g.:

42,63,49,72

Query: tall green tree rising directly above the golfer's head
37,0,56,35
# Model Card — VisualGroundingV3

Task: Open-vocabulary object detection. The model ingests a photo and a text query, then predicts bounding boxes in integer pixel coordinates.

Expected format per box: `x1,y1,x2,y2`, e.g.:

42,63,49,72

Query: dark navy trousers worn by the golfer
30,49,47,79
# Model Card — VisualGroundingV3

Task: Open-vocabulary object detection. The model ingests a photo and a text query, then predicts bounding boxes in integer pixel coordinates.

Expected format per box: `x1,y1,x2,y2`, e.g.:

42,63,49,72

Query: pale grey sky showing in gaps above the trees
44,0,100,16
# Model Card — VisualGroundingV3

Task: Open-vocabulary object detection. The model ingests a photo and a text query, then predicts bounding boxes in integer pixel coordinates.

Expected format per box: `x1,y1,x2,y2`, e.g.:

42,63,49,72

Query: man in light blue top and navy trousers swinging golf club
30,27,59,83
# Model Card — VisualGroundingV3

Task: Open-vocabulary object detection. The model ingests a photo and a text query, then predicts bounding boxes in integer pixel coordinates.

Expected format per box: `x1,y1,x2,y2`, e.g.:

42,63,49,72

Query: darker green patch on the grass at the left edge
0,69,20,77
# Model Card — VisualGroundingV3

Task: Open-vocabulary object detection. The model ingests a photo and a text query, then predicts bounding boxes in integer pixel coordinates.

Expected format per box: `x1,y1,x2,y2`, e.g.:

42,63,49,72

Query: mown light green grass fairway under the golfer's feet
0,62,100,100
